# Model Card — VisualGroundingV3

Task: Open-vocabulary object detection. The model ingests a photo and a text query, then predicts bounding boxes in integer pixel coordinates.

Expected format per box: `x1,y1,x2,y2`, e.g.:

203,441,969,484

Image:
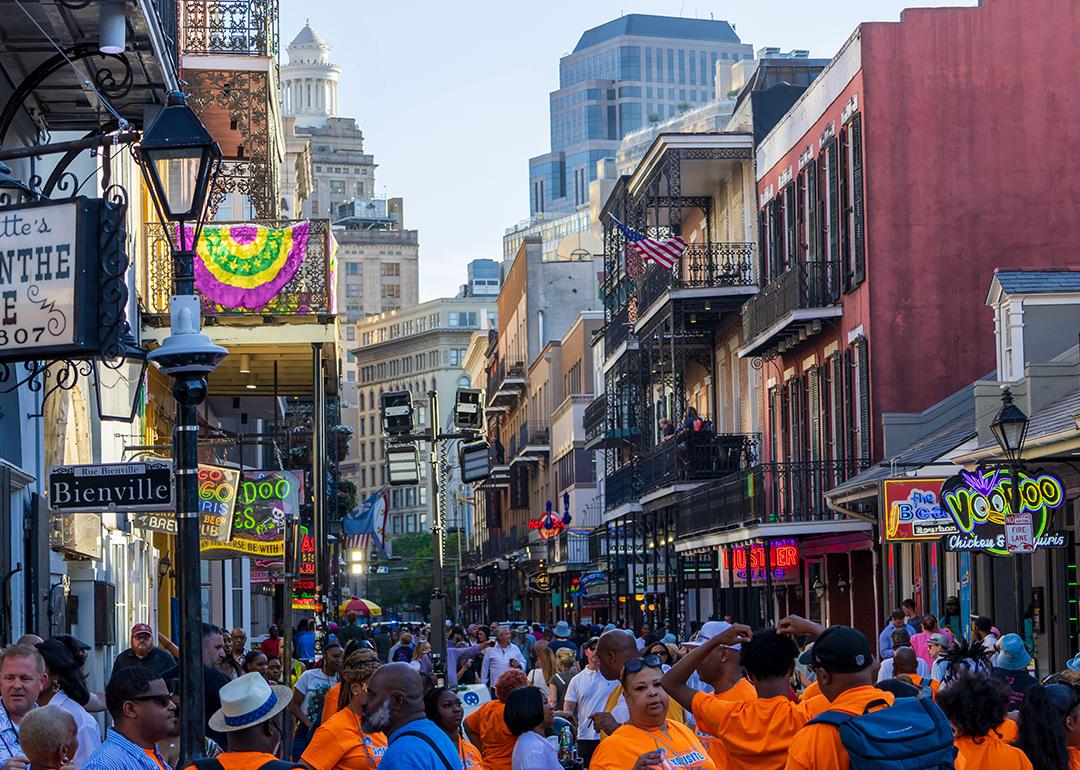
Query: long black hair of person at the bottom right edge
1016,681,1080,770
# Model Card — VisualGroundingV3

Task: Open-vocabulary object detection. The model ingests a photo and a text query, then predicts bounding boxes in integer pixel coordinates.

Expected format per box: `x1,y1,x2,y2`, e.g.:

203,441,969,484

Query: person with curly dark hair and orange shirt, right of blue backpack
936,674,1031,770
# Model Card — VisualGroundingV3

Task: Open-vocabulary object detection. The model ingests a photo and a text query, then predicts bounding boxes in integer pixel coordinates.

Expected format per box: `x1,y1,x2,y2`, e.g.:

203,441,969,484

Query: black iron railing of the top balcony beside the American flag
637,243,755,311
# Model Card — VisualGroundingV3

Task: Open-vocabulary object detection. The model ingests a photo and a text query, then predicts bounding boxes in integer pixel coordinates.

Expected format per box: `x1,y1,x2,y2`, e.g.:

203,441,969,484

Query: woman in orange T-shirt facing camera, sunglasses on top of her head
589,656,716,770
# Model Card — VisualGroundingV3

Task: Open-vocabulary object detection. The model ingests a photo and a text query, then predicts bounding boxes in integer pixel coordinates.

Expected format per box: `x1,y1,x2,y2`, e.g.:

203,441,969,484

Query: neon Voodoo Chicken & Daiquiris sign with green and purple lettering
942,469,1067,556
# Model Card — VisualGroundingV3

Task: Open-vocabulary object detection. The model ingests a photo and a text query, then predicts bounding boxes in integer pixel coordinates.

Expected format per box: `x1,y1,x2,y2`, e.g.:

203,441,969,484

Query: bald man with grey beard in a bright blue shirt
361,663,462,770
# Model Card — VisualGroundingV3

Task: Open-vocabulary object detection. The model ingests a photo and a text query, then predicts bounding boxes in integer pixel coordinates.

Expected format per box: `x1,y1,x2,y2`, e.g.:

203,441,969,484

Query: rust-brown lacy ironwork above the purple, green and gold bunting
187,69,281,219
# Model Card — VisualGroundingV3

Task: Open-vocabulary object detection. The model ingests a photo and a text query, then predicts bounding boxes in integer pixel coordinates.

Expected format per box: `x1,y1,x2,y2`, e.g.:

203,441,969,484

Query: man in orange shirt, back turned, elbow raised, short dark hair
663,625,828,770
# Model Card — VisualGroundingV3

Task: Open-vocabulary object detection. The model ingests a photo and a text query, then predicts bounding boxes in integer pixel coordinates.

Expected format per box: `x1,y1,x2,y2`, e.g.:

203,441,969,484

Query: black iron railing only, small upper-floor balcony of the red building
743,261,840,341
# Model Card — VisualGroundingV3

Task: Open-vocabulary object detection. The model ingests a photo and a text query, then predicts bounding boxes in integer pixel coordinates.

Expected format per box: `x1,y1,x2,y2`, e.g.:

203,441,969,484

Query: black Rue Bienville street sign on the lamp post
49,460,173,513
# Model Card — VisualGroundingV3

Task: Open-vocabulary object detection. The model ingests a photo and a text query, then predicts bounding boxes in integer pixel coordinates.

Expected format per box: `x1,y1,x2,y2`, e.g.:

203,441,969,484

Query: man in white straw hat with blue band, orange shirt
186,672,298,770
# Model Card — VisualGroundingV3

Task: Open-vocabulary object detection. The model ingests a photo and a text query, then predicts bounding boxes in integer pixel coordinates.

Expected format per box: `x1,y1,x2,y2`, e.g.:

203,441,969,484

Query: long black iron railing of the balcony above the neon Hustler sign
678,459,870,537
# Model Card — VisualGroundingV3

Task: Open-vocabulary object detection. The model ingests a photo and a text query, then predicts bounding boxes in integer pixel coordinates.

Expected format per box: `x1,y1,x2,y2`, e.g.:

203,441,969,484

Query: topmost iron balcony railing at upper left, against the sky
180,0,279,58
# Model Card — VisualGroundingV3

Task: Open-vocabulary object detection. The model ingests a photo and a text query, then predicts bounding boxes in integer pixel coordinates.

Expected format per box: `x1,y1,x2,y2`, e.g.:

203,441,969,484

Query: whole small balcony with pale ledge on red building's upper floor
739,261,842,356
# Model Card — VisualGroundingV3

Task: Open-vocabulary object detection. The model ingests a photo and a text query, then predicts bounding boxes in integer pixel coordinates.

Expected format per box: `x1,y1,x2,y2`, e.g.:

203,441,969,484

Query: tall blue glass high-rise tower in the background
529,14,754,216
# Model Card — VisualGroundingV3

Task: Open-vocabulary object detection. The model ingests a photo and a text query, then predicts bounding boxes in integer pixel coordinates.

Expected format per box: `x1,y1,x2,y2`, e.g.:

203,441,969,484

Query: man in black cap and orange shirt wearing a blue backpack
778,616,896,770
